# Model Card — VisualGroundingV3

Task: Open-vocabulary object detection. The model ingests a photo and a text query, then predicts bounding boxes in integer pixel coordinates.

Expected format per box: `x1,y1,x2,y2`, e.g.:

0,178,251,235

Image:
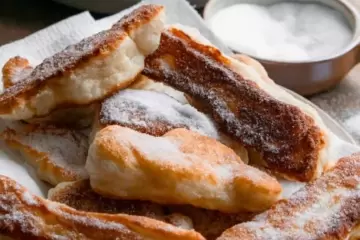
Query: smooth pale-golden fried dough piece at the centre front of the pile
86,125,281,213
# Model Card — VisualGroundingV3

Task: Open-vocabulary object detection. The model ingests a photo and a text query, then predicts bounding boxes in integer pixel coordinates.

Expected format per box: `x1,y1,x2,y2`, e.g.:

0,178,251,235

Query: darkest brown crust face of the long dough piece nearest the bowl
143,28,325,181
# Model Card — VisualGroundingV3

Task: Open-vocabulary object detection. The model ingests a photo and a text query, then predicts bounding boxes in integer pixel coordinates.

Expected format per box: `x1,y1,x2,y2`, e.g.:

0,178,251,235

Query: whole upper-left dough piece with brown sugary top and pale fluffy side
0,5,164,120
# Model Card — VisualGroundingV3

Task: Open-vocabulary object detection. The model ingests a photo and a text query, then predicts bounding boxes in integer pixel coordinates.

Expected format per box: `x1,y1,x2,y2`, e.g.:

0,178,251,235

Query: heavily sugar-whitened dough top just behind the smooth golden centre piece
100,90,219,138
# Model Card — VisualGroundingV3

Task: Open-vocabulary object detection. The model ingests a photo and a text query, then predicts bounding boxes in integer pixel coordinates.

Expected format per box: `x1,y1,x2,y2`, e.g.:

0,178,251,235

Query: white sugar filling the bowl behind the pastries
208,2,353,61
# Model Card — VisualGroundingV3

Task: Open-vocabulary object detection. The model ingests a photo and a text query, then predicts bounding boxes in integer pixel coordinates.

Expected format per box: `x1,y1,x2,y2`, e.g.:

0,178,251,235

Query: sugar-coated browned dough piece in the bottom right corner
218,153,360,240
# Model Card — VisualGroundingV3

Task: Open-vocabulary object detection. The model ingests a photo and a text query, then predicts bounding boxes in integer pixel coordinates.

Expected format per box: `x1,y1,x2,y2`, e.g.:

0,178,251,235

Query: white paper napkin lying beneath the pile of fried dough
0,0,360,199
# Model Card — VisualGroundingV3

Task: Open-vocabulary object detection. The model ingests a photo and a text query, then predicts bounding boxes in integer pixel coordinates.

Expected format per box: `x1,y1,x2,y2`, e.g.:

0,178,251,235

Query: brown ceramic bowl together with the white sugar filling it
204,0,360,95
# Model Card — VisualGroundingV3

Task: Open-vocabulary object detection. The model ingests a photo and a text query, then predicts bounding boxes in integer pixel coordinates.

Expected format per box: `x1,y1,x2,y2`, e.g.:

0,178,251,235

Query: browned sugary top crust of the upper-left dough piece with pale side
0,5,163,114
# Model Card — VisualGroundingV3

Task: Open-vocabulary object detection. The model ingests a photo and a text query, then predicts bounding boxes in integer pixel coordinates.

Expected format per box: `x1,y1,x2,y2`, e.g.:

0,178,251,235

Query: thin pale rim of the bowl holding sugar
203,0,360,64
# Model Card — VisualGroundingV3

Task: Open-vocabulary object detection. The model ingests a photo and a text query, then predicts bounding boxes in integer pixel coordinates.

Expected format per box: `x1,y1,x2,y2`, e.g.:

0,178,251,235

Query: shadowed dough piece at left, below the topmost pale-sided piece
0,124,89,185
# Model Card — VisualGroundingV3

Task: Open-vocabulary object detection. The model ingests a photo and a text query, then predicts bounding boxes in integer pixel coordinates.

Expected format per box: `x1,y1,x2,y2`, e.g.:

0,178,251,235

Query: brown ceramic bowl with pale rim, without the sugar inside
204,0,360,95
